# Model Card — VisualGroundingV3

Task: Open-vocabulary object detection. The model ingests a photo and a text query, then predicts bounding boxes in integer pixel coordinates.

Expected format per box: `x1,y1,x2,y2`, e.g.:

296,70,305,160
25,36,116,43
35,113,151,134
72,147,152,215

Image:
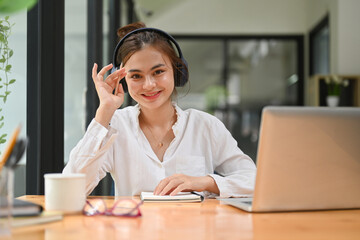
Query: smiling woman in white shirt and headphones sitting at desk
63,23,256,197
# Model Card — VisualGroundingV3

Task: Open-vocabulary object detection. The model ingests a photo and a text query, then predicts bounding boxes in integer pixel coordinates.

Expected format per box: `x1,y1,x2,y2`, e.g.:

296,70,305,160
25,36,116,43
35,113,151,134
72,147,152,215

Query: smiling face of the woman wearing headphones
124,46,174,109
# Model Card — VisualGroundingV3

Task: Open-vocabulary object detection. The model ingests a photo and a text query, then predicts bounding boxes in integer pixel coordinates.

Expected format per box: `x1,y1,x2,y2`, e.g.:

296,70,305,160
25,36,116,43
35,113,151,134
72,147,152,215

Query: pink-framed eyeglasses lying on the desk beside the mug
83,199,143,217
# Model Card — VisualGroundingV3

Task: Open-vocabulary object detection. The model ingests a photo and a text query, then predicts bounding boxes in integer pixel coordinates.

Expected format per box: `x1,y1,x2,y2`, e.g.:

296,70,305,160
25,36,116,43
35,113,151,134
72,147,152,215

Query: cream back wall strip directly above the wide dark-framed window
142,0,306,34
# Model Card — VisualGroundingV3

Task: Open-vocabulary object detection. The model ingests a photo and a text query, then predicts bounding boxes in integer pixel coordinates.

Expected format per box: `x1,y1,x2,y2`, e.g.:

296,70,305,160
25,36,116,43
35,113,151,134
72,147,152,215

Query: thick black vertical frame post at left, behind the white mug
26,0,65,194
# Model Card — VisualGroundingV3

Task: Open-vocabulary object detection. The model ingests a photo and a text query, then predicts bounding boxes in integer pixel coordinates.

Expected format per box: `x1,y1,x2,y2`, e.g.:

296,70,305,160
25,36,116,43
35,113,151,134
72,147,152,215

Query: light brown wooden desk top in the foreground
2,196,360,240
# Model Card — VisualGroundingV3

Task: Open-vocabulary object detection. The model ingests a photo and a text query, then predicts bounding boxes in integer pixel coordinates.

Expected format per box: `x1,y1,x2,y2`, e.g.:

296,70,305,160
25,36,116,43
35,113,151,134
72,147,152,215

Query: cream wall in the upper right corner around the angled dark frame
307,0,360,75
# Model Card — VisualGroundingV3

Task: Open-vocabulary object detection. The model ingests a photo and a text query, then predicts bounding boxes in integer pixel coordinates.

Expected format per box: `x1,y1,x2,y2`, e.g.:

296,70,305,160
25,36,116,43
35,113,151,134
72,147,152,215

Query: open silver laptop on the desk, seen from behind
221,107,360,212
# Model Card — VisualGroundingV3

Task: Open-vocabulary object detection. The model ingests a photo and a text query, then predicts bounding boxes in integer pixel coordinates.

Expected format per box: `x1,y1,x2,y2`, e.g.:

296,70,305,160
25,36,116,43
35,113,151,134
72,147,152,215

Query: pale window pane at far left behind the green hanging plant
0,10,27,197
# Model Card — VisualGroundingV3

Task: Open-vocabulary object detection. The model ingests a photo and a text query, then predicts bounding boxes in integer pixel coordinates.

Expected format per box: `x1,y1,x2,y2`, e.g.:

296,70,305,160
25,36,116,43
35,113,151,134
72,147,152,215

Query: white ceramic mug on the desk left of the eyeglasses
44,173,86,213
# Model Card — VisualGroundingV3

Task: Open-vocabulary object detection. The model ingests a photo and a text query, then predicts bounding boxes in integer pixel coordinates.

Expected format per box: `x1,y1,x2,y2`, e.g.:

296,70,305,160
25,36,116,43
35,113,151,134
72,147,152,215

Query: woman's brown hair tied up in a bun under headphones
117,22,187,83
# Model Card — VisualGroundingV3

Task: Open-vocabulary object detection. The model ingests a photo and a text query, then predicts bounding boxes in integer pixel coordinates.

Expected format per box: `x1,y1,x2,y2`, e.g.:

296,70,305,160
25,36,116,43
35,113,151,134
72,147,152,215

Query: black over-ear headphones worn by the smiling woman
111,28,189,92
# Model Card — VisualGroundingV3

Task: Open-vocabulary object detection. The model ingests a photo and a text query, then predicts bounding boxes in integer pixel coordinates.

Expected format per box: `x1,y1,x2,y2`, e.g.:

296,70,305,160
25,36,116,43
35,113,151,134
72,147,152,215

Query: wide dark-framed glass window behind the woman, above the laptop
174,35,303,160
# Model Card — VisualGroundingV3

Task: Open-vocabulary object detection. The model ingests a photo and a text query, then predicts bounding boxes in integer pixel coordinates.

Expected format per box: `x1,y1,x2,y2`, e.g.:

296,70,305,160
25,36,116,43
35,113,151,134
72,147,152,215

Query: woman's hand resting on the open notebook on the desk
154,174,219,196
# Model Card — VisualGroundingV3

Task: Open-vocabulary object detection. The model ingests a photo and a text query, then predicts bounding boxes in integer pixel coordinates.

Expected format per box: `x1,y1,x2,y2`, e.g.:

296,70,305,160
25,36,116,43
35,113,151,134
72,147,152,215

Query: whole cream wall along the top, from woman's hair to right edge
140,0,360,74
